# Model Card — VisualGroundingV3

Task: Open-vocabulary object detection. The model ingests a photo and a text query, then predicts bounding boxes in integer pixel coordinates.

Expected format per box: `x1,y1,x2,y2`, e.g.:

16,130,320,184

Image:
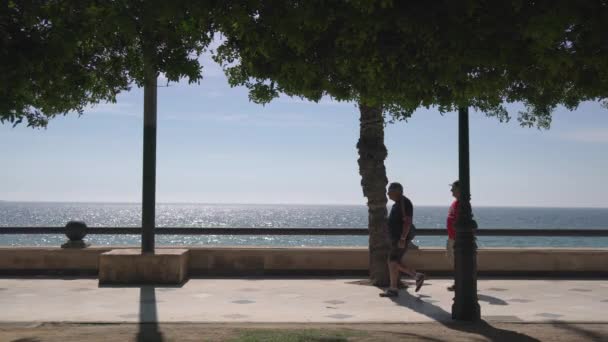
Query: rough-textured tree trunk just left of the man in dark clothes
357,103,389,286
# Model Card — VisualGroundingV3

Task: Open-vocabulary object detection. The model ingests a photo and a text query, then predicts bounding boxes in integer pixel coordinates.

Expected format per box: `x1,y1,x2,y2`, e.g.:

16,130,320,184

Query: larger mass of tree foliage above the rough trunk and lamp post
217,0,608,127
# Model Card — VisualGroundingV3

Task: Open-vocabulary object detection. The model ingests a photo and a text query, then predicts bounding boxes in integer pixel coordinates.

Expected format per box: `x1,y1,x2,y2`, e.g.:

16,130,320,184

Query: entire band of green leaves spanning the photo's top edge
5,0,608,128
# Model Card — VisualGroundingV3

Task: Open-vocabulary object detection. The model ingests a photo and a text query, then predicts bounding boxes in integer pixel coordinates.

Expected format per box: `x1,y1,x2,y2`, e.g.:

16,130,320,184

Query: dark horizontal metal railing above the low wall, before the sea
0,227,608,237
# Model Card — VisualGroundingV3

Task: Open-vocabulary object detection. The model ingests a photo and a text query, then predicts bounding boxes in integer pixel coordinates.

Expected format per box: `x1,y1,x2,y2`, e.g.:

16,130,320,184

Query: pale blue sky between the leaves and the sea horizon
0,51,608,207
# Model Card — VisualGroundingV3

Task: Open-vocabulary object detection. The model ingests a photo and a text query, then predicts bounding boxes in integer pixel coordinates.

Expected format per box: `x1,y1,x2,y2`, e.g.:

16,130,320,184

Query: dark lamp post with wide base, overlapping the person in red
452,107,481,321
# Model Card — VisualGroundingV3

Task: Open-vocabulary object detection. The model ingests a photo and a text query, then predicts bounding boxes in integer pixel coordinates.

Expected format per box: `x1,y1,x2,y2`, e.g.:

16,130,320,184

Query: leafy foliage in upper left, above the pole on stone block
0,0,213,127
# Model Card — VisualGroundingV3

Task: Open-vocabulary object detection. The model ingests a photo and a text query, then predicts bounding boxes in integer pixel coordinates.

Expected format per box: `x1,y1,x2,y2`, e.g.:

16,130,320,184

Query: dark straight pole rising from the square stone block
141,68,157,254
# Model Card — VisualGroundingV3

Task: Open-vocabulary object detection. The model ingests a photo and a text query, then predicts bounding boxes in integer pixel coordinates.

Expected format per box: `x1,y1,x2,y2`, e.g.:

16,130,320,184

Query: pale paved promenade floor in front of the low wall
0,278,608,323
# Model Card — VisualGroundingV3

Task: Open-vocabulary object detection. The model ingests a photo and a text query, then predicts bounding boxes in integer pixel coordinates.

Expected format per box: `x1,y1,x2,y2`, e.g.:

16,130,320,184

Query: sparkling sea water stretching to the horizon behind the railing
0,202,608,247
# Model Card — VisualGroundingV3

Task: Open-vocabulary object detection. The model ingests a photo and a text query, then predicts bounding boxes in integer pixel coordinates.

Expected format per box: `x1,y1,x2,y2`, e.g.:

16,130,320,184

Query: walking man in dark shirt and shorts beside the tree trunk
380,183,424,297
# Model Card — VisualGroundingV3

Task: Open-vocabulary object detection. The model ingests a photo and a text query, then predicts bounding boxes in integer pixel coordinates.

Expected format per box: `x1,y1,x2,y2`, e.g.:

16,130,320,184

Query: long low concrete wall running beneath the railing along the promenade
0,247,608,276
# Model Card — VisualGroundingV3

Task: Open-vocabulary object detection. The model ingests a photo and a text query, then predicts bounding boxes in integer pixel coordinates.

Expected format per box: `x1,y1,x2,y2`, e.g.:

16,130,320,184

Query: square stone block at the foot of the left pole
99,249,189,285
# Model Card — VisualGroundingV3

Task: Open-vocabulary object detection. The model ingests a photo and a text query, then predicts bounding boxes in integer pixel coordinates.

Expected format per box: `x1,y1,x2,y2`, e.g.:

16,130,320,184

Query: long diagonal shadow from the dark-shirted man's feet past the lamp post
391,291,539,342
